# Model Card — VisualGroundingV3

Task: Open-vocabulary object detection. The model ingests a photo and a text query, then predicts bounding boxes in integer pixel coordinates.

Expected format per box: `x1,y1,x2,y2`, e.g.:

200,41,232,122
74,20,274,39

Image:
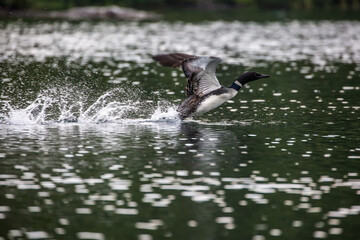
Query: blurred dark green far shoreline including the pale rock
0,0,360,21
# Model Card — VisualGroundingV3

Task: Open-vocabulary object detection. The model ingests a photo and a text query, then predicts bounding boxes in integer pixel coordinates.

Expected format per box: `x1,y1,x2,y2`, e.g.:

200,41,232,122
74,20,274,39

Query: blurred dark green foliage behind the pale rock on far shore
0,0,360,11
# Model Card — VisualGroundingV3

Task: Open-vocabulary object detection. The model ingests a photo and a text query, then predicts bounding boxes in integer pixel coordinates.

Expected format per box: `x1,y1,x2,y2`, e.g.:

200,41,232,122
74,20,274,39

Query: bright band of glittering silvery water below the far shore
0,21,360,65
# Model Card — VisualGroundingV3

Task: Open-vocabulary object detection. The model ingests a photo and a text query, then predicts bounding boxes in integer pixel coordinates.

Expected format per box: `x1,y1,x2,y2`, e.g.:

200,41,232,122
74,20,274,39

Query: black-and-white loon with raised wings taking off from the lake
152,53,270,119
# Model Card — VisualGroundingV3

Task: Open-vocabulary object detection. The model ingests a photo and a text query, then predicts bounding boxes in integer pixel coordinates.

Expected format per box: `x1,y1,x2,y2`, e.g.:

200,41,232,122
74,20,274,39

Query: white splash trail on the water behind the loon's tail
0,86,179,125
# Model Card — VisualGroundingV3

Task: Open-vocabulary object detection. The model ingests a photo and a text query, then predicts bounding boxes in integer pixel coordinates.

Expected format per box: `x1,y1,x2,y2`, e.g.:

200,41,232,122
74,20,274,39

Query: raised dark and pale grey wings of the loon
153,53,221,97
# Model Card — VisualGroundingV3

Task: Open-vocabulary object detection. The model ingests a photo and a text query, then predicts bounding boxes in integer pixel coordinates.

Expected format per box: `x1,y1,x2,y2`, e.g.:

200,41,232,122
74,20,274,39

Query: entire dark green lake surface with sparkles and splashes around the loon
0,21,360,240
